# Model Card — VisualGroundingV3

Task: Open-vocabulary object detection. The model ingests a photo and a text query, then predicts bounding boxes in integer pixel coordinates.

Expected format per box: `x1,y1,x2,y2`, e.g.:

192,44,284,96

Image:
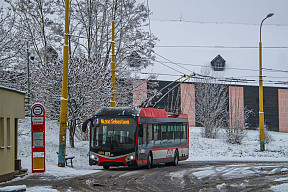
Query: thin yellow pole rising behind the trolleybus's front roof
110,21,115,107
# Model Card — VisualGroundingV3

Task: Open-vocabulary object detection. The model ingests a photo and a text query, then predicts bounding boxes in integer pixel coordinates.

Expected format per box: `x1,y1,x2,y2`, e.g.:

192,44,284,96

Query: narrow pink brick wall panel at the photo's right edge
278,89,288,132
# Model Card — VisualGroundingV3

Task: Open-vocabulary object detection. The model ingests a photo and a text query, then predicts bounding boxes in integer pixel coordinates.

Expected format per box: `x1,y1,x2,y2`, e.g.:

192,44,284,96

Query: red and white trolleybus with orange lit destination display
82,107,189,169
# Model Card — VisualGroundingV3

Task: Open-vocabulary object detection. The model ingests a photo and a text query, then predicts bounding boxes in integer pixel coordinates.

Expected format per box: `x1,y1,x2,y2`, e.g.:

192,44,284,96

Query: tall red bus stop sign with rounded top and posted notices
31,103,45,173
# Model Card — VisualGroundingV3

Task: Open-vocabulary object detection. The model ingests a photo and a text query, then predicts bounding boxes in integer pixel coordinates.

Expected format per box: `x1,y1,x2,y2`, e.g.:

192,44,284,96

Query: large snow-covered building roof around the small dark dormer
143,20,288,88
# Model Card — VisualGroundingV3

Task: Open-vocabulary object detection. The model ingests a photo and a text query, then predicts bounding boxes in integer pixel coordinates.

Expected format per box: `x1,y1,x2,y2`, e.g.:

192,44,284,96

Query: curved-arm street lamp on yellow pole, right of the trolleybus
259,13,274,151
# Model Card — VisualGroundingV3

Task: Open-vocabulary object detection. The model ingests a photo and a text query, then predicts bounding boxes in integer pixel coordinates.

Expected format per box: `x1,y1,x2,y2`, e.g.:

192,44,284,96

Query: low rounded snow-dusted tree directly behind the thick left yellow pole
37,58,111,147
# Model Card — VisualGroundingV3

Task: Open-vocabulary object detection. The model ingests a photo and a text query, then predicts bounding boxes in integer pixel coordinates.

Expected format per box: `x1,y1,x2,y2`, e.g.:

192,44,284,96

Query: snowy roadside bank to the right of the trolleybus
188,127,288,161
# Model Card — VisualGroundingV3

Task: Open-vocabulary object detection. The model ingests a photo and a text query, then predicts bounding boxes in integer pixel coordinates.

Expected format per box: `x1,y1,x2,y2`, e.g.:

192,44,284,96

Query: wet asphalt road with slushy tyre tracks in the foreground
0,162,288,192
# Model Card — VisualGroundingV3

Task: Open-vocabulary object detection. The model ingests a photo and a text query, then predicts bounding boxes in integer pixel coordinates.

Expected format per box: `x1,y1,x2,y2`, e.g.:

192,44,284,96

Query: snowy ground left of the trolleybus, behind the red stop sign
18,118,102,177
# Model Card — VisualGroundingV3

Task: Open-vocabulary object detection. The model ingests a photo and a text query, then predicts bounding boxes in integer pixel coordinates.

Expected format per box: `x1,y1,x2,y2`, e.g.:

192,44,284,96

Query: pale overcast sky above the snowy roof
137,0,288,25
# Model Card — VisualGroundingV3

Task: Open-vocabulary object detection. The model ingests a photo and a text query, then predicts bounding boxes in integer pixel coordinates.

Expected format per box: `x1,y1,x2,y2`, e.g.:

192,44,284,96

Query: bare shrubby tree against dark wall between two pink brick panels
195,70,228,138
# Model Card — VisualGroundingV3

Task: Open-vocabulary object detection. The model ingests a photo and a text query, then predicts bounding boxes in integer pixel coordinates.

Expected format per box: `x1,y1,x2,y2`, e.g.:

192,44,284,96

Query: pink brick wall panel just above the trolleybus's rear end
180,83,196,126
